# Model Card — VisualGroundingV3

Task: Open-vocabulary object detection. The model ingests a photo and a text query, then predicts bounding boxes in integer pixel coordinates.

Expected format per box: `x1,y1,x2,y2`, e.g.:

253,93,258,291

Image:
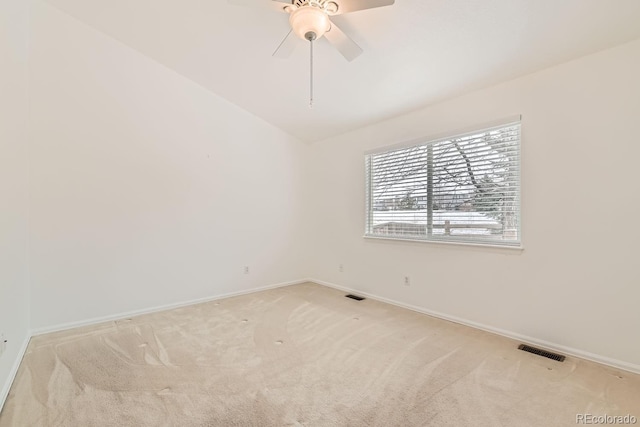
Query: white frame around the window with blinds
363,115,524,250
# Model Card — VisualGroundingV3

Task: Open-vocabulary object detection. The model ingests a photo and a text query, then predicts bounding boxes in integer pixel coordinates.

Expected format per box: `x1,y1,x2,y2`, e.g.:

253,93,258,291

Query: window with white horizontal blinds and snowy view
365,121,520,247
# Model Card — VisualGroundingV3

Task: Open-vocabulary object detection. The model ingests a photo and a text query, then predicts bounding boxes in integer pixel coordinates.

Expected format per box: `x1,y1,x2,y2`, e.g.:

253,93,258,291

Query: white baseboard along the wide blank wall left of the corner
31,279,309,336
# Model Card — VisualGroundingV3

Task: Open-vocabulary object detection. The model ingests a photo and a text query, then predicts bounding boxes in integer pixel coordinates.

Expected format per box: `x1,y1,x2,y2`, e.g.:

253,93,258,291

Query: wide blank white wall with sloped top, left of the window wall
30,2,308,330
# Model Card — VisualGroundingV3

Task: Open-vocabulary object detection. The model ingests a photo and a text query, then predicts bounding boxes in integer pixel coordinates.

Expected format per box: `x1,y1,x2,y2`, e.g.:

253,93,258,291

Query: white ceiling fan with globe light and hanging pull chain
228,0,395,106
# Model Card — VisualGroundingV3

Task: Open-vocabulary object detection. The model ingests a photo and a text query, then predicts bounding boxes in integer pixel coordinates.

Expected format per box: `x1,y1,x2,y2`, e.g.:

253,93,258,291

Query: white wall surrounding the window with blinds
311,41,640,370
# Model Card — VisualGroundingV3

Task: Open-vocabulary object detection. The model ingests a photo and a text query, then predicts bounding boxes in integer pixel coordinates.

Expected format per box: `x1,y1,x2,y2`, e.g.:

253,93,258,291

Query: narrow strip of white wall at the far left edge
0,0,29,406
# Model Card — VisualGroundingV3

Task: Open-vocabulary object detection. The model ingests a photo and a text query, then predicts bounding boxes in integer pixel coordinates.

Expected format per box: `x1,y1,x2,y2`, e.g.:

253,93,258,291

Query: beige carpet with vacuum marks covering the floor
0,284,640,427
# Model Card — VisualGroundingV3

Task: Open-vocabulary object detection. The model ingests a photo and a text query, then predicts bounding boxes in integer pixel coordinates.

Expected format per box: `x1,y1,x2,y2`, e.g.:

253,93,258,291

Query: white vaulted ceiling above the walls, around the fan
47,0,640,141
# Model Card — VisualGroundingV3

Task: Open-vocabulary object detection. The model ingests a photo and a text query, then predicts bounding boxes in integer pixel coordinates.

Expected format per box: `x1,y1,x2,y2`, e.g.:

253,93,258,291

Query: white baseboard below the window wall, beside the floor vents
307,279,640,374
